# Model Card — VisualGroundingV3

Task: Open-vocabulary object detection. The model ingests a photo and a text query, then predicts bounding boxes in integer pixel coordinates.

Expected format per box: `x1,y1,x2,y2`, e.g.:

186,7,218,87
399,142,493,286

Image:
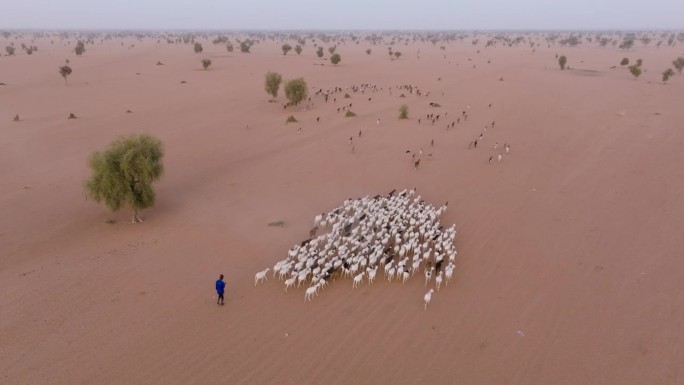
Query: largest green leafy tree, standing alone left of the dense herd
84,134,164,223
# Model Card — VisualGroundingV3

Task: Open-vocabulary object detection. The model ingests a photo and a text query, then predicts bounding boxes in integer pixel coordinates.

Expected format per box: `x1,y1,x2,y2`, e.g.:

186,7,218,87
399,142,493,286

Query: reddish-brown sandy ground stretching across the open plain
0,33,684,384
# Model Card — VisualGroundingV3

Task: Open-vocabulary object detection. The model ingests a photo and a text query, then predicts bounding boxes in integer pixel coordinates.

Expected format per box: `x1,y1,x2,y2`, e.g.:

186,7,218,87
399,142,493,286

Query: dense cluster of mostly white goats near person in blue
254,189,457,309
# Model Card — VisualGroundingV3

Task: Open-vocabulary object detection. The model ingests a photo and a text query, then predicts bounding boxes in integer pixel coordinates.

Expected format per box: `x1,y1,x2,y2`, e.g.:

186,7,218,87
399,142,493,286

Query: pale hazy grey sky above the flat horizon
0,0,684,30
